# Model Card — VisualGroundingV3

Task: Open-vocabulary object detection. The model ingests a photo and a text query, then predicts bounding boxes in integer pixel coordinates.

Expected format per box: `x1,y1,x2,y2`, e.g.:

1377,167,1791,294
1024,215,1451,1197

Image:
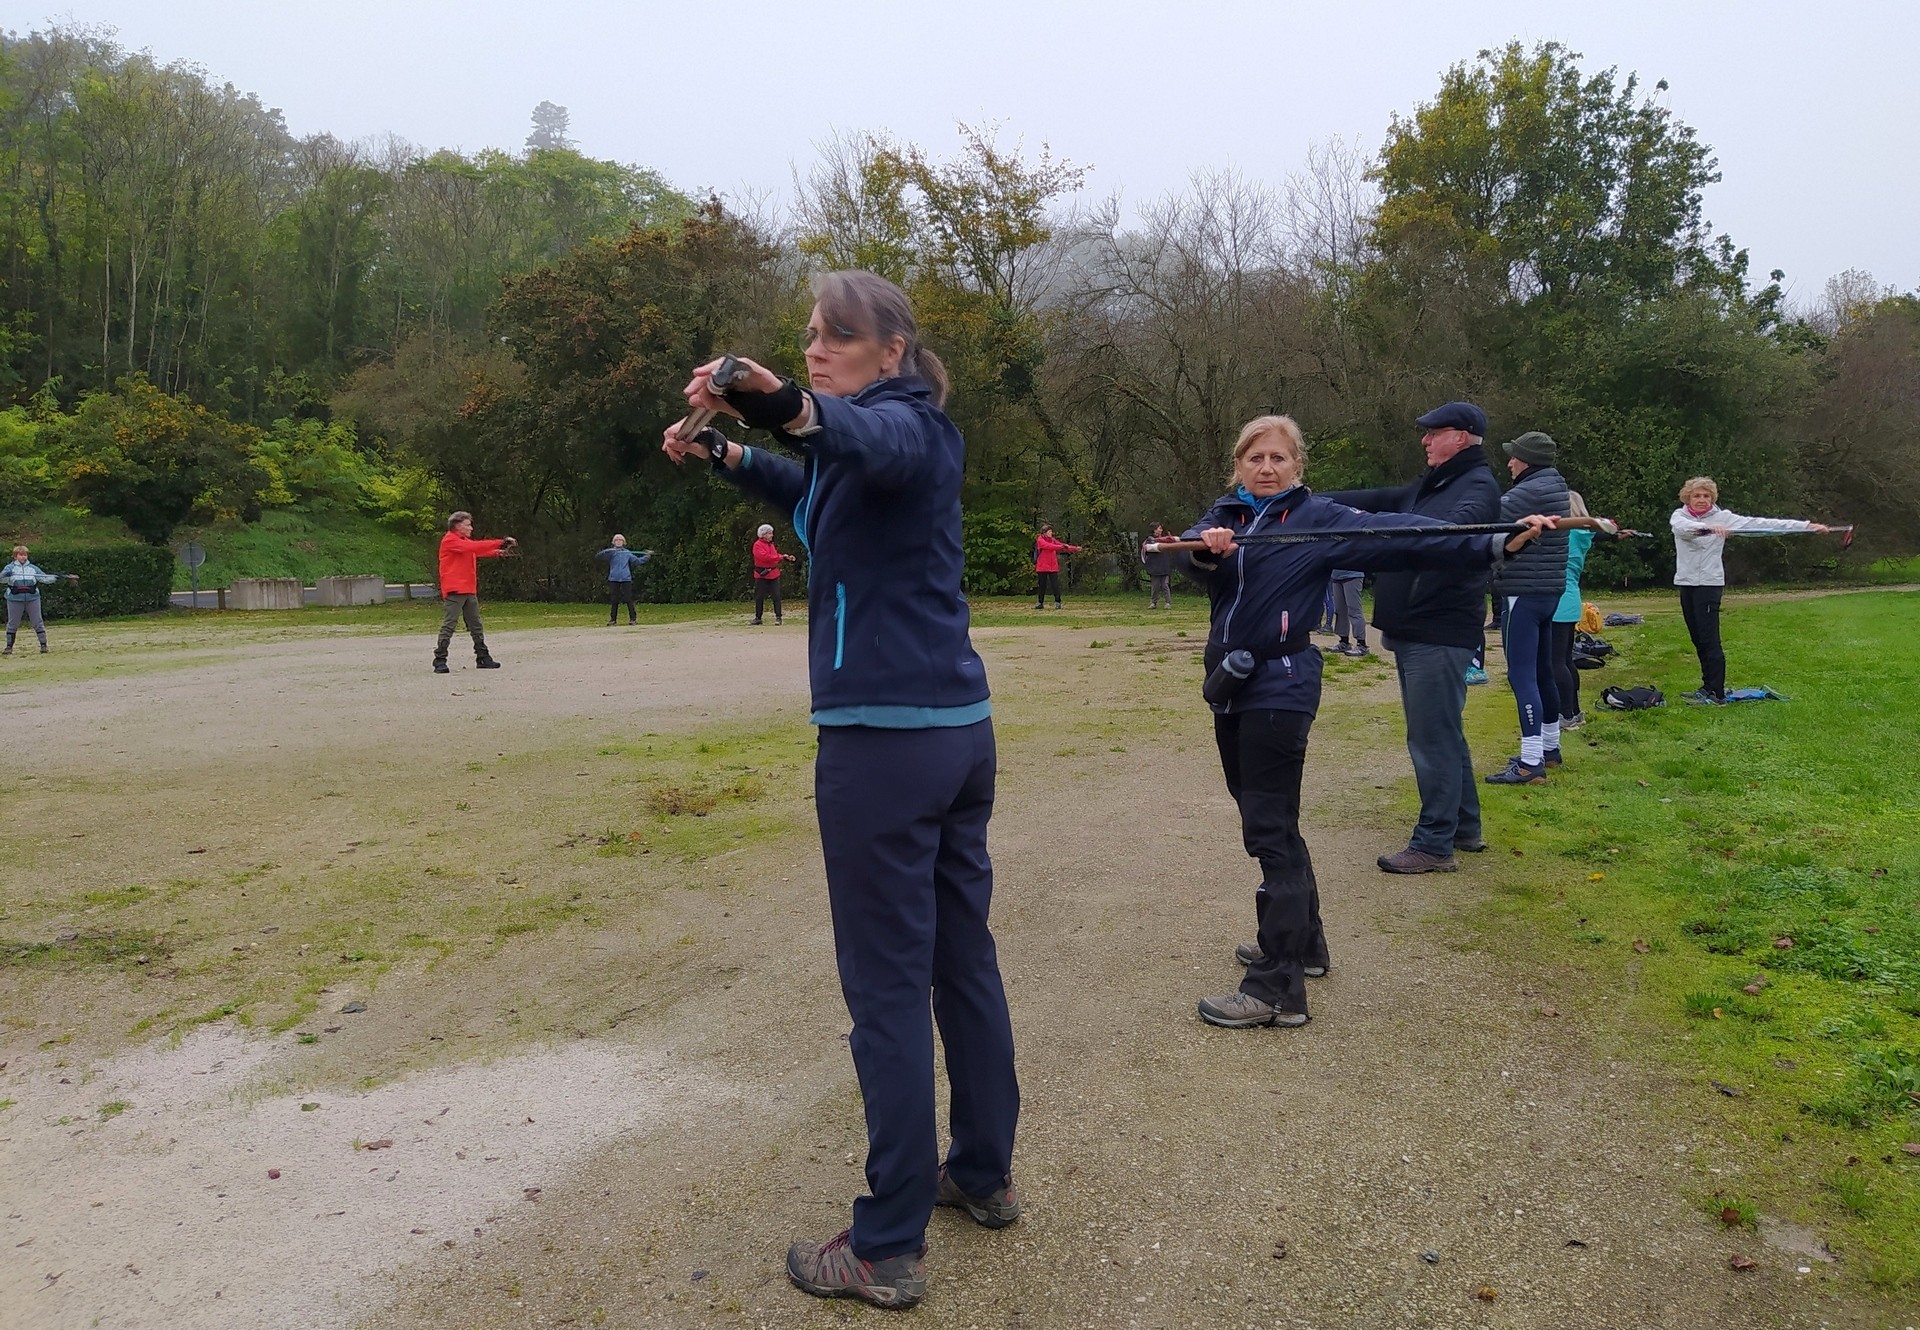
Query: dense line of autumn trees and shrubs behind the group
0,31,1920,599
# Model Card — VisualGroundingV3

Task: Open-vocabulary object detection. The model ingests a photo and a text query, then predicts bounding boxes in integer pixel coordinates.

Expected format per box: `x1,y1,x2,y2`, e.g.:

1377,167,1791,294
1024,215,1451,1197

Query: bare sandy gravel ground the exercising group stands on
0,626,1876,1330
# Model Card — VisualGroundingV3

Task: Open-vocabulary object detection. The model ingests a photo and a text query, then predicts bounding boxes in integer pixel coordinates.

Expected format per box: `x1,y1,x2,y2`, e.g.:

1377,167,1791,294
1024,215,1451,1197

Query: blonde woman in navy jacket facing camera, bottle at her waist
1185,416,1548,1029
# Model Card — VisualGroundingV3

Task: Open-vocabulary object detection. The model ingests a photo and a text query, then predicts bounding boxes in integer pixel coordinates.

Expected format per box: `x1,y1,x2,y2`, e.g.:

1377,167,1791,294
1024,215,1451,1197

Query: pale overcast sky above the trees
26,0,1920,301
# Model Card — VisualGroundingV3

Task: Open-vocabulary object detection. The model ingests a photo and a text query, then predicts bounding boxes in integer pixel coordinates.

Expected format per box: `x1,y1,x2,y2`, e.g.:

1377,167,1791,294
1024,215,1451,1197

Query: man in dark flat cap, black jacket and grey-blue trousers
1327,401,1500,873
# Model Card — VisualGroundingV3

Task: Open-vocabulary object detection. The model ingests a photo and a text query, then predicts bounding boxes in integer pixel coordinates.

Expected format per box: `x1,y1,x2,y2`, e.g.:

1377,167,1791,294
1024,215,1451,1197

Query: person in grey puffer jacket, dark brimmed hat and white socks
1486,430,1569,785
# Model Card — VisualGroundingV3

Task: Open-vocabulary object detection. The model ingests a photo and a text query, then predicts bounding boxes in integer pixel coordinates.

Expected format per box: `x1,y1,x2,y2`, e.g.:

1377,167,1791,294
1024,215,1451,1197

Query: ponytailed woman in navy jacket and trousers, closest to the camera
664,273,1020,1307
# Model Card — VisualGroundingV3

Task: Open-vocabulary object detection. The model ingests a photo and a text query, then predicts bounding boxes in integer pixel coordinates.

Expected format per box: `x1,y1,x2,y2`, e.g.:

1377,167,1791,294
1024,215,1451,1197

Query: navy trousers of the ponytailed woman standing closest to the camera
814,720,1020,1261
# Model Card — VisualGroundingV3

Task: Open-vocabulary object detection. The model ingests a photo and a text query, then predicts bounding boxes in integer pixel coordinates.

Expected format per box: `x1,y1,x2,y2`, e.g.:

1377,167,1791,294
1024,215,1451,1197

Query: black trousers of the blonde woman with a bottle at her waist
1213,710,1327,1011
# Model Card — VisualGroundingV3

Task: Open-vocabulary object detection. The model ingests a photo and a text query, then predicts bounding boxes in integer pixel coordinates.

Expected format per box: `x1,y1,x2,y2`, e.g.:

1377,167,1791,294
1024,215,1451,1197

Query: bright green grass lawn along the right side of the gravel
1469,591,1920,1294
